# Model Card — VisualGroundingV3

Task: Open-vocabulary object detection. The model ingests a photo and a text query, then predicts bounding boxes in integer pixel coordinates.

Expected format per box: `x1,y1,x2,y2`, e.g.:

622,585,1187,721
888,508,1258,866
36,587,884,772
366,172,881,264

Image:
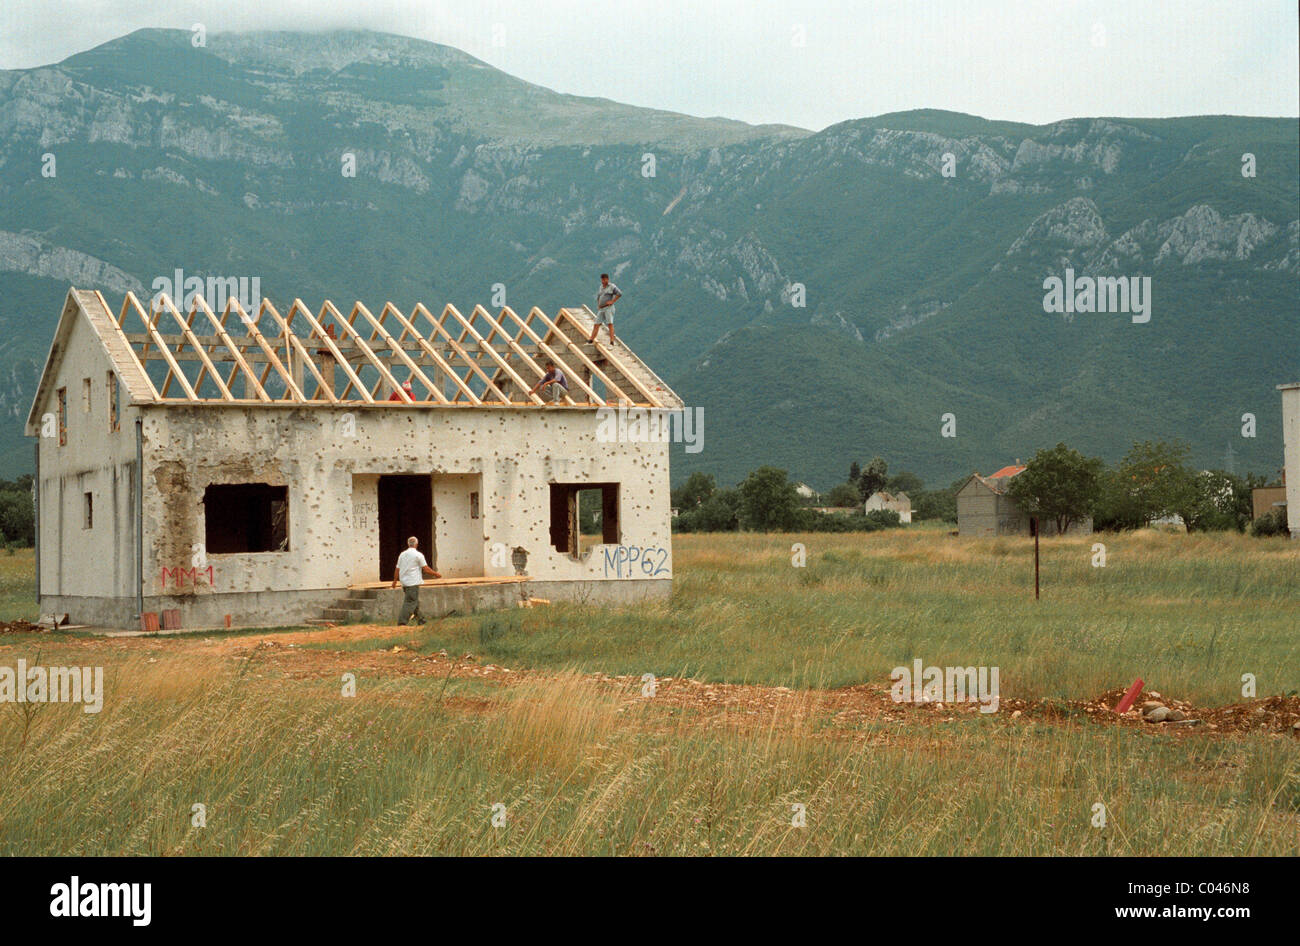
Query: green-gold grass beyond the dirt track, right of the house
390,530,1300,704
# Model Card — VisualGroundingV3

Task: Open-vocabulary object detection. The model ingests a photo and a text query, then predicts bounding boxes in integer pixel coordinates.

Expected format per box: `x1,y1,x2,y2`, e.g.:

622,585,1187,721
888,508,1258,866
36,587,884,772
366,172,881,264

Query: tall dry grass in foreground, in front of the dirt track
0,656,1300,855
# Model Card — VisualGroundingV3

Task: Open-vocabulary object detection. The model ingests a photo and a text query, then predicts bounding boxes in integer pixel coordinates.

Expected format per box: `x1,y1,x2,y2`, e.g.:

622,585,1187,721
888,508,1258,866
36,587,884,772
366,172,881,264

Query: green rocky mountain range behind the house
0,30,1300,487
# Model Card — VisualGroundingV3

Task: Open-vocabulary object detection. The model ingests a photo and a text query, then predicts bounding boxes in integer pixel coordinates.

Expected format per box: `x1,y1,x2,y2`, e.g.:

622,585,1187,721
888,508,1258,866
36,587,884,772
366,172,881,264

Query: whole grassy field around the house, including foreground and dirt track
0,529,1300,855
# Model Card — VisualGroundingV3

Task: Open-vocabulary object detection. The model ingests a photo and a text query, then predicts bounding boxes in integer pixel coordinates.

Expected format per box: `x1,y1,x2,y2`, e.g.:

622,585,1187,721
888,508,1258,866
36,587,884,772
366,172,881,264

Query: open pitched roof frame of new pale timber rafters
53,288,680,409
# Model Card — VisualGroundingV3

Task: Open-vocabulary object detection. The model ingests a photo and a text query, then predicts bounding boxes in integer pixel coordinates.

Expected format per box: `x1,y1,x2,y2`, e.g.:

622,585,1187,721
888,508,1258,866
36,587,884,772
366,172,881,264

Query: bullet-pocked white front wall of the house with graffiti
143,404,672,595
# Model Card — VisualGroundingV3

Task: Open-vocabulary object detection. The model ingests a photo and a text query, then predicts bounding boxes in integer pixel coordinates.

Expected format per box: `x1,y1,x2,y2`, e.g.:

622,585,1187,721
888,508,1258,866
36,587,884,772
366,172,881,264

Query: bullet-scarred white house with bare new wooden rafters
26,288,683,628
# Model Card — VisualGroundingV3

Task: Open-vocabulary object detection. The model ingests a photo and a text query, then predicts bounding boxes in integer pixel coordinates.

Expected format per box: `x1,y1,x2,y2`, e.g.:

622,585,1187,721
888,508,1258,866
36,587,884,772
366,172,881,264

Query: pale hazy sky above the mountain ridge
0,0,1300,129
